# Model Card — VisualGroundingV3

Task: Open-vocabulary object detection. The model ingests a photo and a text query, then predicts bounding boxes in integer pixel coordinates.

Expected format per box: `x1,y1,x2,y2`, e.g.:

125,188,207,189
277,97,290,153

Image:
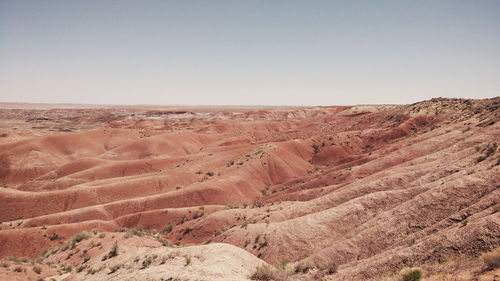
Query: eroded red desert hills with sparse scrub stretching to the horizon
0,97,500,281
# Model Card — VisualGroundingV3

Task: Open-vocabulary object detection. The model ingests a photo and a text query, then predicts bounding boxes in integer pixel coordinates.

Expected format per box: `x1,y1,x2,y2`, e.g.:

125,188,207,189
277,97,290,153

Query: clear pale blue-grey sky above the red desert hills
0,0,500,106
